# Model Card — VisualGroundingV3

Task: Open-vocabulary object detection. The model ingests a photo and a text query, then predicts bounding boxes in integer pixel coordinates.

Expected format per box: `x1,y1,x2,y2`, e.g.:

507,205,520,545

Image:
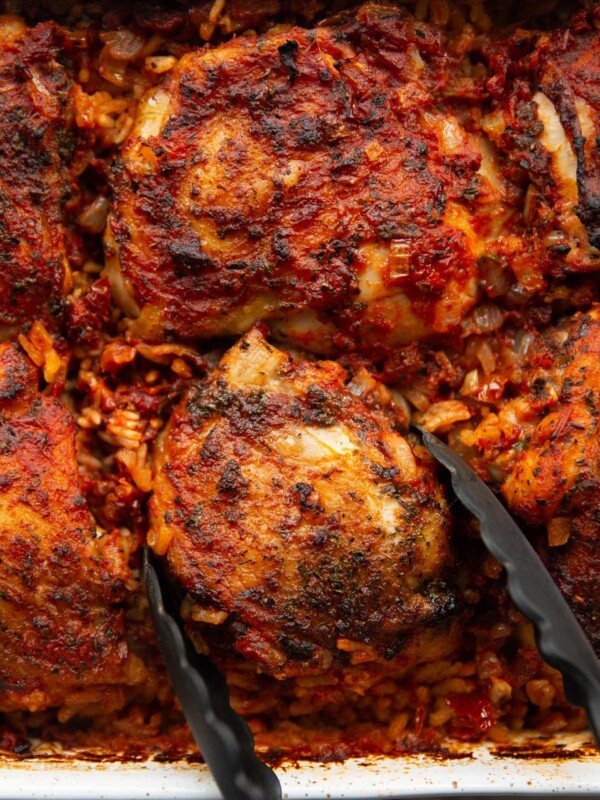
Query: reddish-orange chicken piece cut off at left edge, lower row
0,344,145,719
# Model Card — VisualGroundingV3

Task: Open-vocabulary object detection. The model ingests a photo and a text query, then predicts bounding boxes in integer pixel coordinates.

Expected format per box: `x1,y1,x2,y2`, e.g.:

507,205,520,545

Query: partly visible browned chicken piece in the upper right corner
483,6,600,291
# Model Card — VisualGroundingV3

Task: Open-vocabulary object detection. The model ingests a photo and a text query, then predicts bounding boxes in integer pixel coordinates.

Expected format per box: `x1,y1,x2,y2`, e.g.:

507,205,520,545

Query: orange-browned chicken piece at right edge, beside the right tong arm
462,305,600,651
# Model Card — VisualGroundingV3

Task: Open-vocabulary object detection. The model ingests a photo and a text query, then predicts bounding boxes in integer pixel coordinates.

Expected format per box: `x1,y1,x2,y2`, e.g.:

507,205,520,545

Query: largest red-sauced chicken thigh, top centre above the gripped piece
106,4,505,357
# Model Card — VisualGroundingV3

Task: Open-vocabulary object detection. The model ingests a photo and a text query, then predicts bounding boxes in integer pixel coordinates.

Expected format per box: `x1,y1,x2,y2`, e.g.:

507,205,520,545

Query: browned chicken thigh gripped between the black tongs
150,329,456,678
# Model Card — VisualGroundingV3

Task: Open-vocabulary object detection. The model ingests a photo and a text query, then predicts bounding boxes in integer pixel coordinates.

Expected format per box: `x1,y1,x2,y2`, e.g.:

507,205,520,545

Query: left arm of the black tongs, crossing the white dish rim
144,546,281,800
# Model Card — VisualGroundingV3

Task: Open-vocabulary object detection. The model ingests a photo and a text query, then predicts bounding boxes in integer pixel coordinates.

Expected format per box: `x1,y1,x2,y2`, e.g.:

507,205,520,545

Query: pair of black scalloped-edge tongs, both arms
144,432,600,800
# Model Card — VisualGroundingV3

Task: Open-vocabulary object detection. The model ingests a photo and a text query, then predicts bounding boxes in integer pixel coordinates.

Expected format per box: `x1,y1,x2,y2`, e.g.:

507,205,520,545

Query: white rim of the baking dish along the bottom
0,735,600,800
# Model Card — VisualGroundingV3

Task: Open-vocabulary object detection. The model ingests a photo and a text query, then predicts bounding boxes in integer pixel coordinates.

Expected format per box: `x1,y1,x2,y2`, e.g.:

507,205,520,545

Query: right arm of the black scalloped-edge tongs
413,425,600,746
